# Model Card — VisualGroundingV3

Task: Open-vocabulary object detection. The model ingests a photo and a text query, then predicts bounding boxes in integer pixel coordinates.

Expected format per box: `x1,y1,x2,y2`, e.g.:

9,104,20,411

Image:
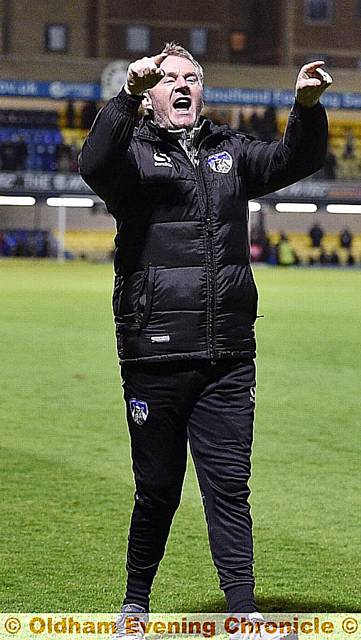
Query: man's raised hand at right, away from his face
296,60,332,107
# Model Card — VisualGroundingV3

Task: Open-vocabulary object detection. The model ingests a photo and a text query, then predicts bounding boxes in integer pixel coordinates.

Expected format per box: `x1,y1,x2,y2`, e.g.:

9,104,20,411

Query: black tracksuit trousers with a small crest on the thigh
121,360,256,612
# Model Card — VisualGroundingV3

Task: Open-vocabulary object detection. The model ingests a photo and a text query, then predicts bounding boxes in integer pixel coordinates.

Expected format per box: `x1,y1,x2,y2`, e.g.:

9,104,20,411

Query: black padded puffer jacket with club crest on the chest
80,91,327,362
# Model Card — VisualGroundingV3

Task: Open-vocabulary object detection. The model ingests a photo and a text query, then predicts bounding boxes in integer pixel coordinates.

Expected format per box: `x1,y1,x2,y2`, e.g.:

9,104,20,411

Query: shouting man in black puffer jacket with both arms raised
80,43,330,614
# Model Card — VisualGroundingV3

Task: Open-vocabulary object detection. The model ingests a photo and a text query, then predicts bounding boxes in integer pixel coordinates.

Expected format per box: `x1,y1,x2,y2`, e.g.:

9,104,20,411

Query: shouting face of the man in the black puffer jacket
148,55,203,129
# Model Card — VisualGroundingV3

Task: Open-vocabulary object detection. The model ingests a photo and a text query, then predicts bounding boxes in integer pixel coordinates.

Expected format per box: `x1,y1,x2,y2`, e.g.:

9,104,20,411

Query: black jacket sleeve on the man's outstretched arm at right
239,102,328,199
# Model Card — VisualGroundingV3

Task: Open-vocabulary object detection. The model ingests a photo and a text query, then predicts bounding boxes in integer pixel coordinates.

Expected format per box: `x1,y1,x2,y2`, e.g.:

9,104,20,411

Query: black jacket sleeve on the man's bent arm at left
79,89,142,211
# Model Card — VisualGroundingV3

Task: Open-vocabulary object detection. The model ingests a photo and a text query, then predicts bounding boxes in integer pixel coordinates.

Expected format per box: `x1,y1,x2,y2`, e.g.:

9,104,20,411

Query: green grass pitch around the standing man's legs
0,260,361,612
